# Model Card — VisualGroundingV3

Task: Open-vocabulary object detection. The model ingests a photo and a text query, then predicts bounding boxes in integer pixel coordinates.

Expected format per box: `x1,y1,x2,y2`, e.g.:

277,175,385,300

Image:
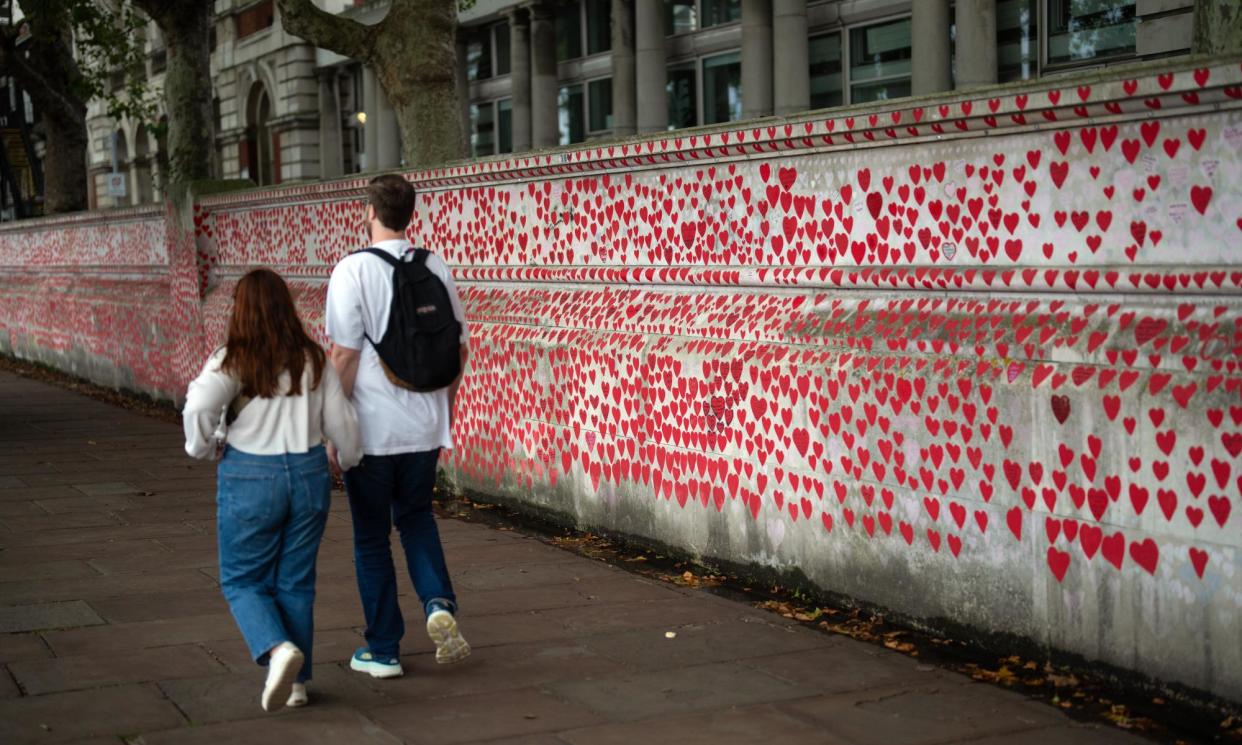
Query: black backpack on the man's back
359,248,462,392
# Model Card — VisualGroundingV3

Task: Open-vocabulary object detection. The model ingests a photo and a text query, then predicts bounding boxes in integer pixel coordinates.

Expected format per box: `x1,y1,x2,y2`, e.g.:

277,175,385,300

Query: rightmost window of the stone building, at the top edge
1048,0,1138,65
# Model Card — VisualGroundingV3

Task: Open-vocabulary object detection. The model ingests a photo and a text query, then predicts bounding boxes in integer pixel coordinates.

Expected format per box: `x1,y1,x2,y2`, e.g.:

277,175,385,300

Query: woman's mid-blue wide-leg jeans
216,446,332,682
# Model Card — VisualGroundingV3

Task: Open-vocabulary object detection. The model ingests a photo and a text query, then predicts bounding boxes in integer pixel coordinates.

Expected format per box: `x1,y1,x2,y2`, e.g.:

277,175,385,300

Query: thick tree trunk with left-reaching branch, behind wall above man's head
277,0,466,168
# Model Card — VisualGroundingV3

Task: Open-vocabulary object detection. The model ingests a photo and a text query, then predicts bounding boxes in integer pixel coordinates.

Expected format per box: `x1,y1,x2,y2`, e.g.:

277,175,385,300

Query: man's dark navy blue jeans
345,448,457,657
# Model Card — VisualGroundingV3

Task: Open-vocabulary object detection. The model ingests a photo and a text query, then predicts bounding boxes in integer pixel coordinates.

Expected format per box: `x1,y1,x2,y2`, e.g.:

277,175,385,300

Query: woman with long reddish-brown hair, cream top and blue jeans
183,269,361,711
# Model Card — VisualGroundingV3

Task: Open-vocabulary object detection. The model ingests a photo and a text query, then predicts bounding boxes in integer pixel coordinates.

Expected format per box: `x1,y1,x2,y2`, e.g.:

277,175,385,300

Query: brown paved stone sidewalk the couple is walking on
0,373,1143,745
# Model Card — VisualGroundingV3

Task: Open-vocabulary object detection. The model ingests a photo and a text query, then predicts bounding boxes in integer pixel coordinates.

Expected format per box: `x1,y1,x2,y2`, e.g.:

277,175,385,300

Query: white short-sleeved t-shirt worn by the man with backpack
325,240,469,456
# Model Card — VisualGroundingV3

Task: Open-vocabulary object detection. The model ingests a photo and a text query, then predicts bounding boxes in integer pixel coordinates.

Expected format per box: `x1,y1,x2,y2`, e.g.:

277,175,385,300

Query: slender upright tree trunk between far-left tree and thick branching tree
134,0,219,184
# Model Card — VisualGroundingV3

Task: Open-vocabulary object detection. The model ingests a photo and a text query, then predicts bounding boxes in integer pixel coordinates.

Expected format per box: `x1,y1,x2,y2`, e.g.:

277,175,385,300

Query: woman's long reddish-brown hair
221,269,325,399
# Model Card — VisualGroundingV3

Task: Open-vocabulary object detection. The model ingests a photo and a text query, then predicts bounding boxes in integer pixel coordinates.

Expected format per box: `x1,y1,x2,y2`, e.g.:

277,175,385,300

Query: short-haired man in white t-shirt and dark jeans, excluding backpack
325,174,471,678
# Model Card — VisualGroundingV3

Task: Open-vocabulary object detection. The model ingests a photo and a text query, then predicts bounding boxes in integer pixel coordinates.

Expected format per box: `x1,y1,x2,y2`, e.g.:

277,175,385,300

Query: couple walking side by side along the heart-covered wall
183,175,469,711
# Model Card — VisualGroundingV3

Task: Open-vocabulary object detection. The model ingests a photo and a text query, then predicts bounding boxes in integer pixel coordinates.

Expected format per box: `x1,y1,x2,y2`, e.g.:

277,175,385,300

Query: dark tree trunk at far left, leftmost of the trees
0,9,89,215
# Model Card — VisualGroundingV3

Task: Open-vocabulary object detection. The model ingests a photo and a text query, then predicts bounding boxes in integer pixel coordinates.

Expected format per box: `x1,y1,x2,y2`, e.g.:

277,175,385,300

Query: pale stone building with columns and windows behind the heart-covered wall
89,0,1194,207
